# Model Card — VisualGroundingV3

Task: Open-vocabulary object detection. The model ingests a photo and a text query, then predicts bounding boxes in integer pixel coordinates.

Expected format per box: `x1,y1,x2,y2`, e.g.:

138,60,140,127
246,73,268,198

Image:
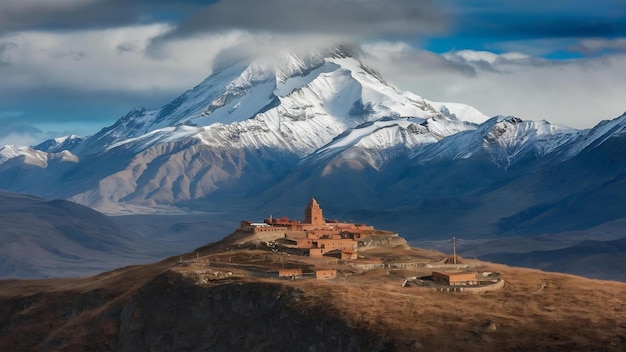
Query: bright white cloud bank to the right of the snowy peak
363,43,626,128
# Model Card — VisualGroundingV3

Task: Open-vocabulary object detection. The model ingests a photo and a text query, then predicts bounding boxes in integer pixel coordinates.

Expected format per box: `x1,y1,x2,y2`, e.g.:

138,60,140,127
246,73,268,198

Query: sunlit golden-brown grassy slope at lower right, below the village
282,265,626,351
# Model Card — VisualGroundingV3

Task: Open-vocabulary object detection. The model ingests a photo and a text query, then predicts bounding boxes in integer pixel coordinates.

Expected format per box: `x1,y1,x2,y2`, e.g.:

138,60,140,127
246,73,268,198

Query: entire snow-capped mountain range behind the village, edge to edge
0,47,626,280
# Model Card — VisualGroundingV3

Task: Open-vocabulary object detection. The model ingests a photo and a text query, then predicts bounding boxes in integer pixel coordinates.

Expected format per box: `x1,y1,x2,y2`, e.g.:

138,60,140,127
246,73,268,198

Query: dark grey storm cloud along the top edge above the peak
155,0,446,39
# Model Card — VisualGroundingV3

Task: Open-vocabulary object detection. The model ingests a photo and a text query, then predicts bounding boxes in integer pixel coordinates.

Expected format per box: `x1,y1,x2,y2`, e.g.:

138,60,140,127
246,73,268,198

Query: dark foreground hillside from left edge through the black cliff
0,271,393,351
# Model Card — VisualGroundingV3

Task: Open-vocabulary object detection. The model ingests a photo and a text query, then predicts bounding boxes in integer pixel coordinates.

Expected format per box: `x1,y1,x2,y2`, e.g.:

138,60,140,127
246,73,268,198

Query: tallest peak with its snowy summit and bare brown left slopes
0,47,486,207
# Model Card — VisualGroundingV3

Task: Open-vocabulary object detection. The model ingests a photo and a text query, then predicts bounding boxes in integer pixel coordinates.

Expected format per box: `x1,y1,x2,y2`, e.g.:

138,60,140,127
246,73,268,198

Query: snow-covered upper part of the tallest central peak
76,48,458,157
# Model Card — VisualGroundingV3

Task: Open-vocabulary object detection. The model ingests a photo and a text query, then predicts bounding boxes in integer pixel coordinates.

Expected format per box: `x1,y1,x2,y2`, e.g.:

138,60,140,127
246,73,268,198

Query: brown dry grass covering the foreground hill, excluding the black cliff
0,238,626,351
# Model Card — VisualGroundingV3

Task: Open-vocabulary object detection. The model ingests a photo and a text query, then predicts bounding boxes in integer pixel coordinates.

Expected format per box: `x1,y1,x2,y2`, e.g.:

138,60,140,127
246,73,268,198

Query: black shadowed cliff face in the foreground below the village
119,273,385,351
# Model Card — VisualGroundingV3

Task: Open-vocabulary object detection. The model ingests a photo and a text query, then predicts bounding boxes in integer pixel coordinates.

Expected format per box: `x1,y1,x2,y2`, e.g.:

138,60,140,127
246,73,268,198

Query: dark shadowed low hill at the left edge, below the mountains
0,191,171,278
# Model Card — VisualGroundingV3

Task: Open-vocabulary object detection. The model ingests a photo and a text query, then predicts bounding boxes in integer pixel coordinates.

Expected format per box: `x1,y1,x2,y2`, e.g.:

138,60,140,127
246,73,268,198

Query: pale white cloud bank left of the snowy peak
0,24,246,93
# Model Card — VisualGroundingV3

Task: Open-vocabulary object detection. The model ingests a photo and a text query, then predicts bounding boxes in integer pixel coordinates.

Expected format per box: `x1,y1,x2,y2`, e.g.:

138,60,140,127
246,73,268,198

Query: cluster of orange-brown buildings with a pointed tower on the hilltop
229,198,504,292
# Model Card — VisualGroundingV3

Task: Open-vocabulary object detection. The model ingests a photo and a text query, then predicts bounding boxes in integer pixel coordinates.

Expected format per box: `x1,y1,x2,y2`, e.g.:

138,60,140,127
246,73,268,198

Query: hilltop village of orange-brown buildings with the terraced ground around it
181,198,504,292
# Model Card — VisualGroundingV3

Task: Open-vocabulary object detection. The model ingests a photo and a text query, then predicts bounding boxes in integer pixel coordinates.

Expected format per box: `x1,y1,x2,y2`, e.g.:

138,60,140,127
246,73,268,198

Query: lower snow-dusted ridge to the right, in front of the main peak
305,115,595,173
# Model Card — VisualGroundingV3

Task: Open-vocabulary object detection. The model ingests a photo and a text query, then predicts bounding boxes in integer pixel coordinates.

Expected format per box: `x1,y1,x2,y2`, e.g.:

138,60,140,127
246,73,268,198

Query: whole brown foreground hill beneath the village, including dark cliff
0,234,626,351
